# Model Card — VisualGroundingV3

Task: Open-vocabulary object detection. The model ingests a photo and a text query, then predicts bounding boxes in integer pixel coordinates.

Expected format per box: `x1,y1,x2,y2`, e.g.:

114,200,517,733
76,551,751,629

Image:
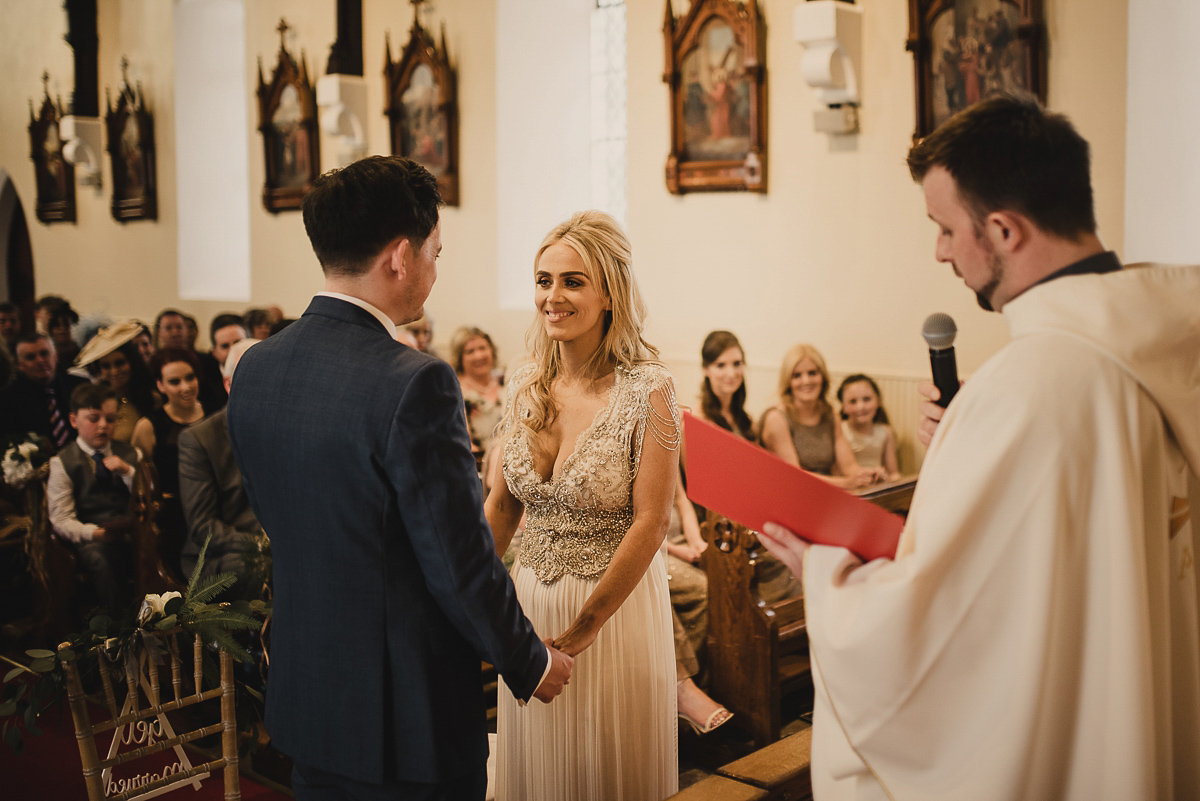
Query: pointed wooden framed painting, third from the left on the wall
258,19,320,213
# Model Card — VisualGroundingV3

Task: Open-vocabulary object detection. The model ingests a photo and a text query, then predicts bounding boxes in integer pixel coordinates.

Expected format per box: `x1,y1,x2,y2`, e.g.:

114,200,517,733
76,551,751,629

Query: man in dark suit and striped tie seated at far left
0,332,88,448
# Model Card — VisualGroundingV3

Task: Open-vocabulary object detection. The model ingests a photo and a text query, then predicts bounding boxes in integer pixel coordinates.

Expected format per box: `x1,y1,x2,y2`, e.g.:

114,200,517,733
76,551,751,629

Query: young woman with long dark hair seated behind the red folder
696,331,804,603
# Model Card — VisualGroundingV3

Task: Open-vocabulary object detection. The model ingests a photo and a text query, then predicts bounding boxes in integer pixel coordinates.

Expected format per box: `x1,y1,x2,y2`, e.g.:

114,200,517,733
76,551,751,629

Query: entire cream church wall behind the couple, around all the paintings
0,0,1127,398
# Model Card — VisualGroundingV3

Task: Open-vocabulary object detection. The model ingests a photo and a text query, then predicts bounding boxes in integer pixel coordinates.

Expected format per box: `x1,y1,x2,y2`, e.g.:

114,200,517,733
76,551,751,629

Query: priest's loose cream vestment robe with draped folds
804,266,1200,801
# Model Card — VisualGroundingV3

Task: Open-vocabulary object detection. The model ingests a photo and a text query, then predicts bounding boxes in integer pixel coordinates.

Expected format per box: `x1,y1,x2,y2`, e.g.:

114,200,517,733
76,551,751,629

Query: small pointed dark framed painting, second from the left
104,59,158,223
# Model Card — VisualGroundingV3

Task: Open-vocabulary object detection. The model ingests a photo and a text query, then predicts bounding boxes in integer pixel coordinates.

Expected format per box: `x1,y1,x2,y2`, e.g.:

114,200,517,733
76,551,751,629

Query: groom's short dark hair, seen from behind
302,156,442,276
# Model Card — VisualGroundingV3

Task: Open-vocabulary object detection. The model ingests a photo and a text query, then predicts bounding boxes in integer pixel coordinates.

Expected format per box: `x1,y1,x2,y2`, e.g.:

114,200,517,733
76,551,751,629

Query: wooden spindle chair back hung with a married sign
59,628,241,801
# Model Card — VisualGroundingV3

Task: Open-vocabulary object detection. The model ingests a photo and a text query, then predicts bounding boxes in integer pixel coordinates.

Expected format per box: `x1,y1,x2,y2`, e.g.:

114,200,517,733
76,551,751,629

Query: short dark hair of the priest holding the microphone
908,95,1096,241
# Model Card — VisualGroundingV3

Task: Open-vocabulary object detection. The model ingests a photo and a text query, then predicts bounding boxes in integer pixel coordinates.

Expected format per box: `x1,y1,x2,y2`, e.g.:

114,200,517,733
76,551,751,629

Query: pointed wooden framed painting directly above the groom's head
383,4,458,206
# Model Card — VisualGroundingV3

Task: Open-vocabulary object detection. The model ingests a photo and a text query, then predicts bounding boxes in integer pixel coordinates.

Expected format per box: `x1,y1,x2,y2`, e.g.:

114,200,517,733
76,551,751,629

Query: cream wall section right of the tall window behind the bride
629,0,1126,424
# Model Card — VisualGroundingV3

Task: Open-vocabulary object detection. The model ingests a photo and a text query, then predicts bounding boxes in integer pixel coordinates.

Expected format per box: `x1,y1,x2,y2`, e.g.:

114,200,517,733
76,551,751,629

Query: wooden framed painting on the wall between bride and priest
662,0,767,194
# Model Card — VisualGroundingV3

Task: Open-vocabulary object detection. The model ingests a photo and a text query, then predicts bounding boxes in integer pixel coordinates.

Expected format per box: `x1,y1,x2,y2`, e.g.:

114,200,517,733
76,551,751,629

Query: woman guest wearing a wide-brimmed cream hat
76,320,155,442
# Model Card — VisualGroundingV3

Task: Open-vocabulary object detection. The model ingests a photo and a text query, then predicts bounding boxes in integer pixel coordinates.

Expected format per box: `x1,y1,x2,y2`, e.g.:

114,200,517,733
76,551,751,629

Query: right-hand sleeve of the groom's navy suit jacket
385,361,548,700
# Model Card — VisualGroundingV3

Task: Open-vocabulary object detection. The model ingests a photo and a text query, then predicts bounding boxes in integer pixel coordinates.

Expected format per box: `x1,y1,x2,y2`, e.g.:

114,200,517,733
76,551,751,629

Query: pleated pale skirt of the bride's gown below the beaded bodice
496,553,679,801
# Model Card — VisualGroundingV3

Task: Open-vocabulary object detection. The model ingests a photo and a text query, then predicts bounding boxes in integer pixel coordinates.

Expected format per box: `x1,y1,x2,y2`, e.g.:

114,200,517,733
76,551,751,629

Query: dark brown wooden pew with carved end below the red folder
702,477,916,748
